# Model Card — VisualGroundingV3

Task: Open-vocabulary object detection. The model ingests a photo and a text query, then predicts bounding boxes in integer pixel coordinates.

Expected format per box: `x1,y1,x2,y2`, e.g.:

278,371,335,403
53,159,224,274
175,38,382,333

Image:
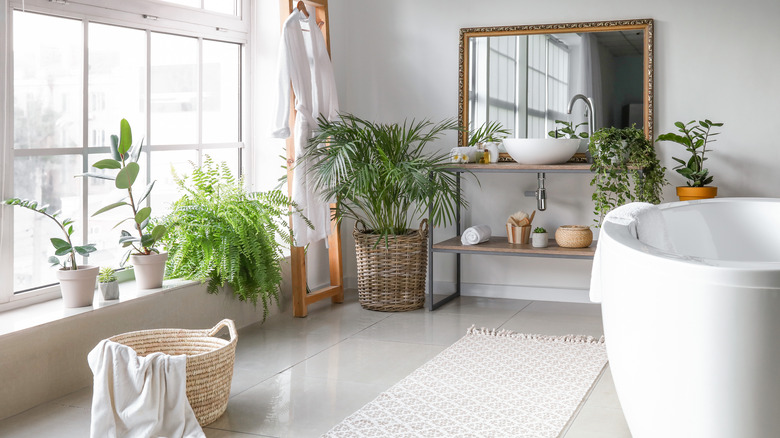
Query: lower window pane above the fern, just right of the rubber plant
151,150,198,217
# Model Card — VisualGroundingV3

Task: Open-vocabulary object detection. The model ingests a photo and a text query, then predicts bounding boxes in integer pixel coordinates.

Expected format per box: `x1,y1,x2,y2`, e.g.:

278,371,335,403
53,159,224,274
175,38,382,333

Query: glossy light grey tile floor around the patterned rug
0,291,631,438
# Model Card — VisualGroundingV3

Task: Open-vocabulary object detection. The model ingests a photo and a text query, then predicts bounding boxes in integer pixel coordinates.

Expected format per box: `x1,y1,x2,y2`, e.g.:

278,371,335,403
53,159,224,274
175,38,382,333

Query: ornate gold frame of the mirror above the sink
458,18,653,146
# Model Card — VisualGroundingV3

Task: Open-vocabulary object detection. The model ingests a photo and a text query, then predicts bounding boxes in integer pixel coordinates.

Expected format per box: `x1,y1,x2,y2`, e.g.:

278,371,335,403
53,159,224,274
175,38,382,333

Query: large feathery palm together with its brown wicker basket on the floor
302,114,460,311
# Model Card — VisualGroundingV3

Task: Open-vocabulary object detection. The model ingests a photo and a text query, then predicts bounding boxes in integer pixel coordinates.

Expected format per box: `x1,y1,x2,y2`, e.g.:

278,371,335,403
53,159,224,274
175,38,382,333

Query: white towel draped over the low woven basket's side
87,339,206,438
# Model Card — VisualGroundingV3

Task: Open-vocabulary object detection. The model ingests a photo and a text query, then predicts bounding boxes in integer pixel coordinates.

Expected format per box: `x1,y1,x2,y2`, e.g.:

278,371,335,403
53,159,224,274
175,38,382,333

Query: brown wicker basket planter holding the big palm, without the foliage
352,219,428,312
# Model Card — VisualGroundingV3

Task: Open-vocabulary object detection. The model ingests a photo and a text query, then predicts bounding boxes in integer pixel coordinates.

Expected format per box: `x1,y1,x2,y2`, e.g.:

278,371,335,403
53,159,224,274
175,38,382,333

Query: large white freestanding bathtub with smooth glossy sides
599,198,780,438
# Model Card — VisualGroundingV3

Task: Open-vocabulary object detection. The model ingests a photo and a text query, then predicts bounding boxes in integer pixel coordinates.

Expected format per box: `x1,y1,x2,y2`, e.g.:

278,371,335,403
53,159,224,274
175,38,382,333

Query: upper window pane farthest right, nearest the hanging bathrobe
203,41,241,143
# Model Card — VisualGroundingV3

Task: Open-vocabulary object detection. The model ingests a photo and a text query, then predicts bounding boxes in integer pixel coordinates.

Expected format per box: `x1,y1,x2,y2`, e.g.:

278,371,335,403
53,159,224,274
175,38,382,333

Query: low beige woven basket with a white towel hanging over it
109,319,238,426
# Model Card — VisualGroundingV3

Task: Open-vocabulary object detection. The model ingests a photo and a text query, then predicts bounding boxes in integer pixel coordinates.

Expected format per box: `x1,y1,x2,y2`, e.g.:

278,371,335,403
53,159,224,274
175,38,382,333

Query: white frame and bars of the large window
0,0,253,311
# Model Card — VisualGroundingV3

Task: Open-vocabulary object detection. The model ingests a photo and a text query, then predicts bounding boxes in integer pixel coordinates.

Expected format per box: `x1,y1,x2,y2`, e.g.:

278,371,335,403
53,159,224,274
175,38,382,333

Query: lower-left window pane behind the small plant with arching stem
14,155,85,291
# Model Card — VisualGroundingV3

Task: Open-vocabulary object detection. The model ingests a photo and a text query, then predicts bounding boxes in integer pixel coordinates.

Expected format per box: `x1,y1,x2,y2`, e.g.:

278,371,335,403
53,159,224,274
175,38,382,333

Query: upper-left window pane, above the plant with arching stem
13,11,84,149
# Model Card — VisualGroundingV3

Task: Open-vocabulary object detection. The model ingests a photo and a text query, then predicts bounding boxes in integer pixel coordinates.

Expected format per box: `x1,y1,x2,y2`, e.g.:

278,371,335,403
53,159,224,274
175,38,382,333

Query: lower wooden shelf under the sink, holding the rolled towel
433,236,596,259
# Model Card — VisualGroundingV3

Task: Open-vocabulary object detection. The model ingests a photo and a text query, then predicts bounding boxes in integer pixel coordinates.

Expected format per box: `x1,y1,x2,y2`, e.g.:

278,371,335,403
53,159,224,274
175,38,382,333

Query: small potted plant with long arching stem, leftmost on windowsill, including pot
3,198,98,307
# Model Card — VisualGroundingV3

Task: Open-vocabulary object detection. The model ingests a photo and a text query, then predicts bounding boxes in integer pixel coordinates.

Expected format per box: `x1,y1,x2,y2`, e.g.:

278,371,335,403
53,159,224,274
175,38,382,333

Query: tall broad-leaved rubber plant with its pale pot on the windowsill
83,119,168,289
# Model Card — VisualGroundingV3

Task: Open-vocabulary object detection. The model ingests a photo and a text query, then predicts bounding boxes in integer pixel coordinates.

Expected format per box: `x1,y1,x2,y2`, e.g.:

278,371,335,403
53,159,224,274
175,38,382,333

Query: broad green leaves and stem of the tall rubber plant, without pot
81,119,166,264
